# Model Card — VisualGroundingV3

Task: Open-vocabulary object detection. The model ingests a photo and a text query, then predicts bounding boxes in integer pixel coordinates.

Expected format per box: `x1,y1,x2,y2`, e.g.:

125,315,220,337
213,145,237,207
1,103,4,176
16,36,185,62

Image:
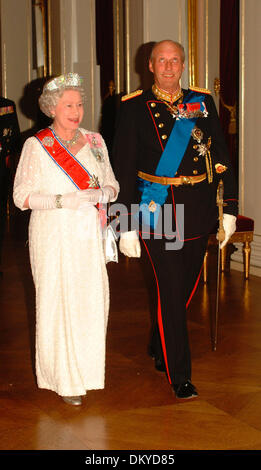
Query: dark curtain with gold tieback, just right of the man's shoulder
219,0,239,177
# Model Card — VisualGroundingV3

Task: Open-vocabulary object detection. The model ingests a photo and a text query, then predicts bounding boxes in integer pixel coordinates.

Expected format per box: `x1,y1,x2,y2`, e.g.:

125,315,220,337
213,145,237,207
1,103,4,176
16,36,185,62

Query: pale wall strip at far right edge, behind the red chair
233,0,261,275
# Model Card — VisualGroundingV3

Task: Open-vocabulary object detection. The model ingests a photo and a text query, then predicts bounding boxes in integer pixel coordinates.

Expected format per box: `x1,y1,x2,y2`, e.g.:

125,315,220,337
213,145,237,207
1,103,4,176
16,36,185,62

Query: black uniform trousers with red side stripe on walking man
144,236,208,384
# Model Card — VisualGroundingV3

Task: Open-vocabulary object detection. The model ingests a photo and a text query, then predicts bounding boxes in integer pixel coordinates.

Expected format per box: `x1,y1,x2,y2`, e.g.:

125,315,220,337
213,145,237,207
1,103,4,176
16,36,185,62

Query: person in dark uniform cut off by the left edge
0,96,20,274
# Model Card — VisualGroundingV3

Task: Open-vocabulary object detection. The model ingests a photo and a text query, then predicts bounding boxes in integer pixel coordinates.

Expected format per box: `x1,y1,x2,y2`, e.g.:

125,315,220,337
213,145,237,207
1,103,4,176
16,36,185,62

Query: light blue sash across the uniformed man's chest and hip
135,91,205,228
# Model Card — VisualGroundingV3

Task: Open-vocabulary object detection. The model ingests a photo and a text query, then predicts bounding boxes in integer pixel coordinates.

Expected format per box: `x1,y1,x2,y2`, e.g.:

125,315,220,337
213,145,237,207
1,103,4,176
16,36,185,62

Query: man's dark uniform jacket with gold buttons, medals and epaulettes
113,86,237,240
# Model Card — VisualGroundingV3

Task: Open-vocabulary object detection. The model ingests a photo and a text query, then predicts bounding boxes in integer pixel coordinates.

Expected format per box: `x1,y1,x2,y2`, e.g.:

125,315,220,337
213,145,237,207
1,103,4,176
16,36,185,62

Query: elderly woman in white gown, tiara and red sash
14,73,119,405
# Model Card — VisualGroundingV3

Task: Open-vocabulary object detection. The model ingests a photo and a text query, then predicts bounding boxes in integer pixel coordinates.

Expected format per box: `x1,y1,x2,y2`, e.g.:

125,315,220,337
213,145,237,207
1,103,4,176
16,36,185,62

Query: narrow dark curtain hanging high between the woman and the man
95,0,114,100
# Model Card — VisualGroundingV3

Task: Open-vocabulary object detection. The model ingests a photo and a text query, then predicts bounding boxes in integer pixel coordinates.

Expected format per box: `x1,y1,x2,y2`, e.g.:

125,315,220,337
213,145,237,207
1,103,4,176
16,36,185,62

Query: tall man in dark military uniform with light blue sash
113,40,237,399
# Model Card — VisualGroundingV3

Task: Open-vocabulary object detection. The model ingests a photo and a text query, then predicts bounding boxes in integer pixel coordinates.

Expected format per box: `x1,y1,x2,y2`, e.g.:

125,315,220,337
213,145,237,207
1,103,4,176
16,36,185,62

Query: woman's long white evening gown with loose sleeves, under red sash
14,129,119,396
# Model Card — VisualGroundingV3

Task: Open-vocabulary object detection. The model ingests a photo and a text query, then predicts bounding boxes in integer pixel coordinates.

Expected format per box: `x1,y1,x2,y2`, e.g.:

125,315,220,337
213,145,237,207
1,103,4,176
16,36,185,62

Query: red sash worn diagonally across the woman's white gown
35,127,100,189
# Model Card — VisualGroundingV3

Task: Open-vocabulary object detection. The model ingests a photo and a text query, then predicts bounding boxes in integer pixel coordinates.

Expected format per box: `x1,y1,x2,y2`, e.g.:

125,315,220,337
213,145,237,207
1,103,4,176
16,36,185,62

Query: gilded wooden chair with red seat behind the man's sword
203,215,254,282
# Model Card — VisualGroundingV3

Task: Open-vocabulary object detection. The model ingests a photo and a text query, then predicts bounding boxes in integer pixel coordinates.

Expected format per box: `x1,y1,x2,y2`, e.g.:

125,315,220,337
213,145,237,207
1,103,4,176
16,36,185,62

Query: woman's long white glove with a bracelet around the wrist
29,191,92,210
